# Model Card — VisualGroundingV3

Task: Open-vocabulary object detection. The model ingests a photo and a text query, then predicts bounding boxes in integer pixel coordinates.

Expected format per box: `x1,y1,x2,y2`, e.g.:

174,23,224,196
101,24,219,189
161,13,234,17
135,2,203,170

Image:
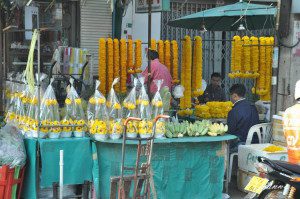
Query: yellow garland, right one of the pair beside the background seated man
193,36,204,97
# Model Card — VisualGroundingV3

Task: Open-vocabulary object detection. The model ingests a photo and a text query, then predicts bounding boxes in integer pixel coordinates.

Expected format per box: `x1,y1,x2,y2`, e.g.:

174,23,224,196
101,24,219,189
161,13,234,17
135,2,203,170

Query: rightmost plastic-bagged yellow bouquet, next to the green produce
151,80,166,138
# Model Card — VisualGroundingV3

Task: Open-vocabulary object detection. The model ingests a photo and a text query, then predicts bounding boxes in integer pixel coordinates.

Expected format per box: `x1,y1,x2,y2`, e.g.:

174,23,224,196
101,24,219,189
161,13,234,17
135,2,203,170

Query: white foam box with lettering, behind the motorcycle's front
238,143,288,173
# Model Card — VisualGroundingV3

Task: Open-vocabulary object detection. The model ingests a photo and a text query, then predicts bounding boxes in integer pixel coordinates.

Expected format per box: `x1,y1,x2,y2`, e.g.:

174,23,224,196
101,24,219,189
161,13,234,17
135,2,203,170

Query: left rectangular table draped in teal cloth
22,138,93,199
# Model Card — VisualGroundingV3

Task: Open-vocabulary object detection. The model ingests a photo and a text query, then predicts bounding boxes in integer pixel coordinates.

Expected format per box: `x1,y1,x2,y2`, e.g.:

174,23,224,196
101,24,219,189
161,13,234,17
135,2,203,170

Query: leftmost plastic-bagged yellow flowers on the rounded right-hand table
87,80,108,141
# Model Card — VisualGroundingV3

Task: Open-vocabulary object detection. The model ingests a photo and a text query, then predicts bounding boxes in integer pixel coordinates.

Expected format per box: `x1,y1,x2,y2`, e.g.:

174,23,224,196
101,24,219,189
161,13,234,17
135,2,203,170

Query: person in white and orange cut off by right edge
283,80,300,164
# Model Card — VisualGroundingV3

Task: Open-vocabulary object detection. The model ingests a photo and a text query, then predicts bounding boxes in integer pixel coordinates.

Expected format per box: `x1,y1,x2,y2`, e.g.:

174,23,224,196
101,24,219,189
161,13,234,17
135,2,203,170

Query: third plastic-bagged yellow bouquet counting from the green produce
123,78,138,138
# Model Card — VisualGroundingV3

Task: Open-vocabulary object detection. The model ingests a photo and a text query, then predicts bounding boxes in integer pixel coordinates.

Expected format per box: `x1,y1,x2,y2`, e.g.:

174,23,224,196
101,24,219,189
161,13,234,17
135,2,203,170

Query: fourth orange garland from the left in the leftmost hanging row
119,39,127,94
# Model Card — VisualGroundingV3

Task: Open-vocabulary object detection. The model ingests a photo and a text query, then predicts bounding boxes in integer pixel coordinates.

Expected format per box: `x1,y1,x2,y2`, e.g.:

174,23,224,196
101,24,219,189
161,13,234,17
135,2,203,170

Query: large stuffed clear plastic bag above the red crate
0,124,26,168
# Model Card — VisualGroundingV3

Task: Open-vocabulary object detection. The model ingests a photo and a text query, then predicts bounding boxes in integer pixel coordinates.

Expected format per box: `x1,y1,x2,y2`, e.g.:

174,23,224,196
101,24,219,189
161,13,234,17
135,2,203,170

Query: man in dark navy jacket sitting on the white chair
227,84,259,153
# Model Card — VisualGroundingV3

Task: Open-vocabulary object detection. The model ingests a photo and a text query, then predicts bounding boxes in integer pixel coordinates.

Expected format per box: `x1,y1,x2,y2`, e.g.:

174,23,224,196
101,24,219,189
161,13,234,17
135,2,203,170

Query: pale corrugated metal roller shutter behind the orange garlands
80,0,112,76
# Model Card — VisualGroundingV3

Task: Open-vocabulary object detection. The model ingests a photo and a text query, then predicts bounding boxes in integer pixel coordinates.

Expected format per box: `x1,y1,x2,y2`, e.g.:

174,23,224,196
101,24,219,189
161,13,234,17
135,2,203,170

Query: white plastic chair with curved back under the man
228,123,272,182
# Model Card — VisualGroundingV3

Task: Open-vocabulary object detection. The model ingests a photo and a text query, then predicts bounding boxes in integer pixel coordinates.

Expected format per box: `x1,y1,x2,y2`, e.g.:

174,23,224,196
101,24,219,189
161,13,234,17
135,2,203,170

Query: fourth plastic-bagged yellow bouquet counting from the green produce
106,78,123,139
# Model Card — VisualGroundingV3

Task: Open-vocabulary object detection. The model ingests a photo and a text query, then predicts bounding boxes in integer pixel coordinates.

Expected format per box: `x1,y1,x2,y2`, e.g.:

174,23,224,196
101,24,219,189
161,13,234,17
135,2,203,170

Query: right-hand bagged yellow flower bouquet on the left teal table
39,79,61,138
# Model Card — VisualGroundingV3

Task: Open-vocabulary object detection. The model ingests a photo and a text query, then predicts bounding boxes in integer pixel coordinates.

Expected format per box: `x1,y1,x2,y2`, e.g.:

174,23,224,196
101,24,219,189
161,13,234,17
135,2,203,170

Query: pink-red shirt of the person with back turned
142,59,172,94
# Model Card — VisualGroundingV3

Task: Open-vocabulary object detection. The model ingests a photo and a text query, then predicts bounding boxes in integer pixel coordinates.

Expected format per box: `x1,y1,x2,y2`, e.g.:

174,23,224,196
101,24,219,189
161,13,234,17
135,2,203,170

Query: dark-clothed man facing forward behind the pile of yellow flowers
199,73,226,103
